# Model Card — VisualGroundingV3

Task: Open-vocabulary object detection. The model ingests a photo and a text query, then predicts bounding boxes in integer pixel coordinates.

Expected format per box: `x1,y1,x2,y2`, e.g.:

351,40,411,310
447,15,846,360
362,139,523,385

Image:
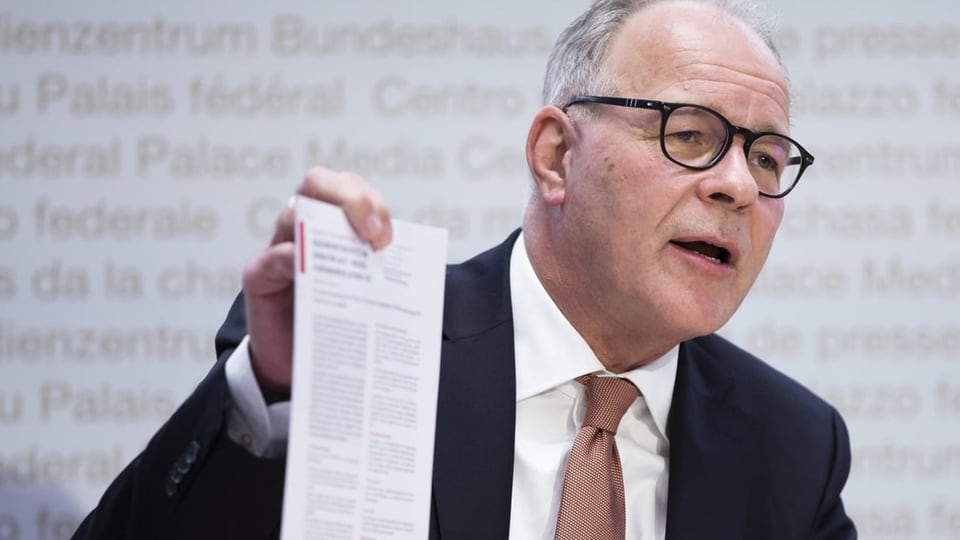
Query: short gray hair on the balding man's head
543,0,786,107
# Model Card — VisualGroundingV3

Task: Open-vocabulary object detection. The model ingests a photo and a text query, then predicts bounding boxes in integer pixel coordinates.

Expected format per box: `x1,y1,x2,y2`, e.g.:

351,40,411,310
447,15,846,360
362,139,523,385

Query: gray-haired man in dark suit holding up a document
77,0,856,540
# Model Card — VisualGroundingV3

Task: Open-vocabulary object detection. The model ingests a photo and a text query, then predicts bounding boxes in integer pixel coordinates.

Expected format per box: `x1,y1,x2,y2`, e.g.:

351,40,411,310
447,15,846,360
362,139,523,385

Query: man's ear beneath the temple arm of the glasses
527,105,574,205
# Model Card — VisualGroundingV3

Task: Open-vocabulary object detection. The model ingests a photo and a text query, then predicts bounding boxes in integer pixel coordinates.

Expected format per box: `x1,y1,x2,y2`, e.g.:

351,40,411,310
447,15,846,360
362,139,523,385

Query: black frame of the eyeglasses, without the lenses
562,96,814,199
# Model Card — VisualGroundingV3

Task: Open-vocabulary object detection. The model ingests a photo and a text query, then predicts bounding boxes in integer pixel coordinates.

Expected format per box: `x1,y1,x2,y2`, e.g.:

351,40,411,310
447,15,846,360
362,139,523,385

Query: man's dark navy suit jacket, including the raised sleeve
75,233,856,540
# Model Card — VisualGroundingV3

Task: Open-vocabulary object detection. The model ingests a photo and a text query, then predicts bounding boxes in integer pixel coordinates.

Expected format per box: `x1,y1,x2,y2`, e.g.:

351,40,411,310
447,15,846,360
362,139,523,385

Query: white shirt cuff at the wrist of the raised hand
224,337,290,458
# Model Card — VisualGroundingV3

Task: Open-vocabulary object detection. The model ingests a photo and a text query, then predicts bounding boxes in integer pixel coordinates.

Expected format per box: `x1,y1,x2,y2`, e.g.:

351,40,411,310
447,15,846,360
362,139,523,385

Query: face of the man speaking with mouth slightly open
562,3,789,350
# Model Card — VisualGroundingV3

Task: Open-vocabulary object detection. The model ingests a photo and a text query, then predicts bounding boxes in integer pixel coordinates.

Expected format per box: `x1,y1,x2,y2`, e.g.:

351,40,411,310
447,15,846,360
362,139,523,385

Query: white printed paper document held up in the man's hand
281,197,447,540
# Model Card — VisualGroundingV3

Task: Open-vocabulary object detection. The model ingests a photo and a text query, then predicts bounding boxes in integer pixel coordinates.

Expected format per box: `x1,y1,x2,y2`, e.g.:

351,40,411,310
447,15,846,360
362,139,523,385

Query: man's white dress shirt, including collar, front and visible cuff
225,234,679,540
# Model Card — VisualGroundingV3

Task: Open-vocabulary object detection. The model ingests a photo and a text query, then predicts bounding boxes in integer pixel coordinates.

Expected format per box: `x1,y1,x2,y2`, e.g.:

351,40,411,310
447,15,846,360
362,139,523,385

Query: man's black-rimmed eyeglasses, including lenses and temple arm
563,96,813,199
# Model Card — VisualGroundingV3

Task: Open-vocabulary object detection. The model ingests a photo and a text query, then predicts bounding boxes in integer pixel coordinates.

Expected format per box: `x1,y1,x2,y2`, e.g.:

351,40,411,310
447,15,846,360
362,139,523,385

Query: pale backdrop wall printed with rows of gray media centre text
0,0,960,540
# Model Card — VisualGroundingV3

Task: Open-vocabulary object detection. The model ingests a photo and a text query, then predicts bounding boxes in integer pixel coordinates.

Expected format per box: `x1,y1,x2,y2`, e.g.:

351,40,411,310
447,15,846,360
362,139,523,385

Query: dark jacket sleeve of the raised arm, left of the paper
73,294,286,539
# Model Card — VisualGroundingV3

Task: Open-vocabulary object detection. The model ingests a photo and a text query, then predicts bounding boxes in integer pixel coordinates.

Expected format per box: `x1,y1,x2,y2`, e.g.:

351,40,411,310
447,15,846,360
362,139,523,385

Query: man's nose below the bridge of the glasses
697,136,760,210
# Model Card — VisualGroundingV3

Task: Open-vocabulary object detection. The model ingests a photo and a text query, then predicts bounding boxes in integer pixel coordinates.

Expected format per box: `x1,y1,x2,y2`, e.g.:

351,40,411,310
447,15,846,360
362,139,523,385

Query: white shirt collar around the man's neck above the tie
510,232,680,437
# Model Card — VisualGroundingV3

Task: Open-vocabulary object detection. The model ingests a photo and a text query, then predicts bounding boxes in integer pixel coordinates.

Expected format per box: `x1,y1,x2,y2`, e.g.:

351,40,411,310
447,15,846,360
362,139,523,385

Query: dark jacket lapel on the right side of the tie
666,336,755,540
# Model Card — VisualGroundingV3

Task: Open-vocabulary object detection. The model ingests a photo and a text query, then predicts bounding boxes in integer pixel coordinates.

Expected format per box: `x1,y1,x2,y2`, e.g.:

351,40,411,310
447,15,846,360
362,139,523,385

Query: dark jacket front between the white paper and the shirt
432,232,517,540
